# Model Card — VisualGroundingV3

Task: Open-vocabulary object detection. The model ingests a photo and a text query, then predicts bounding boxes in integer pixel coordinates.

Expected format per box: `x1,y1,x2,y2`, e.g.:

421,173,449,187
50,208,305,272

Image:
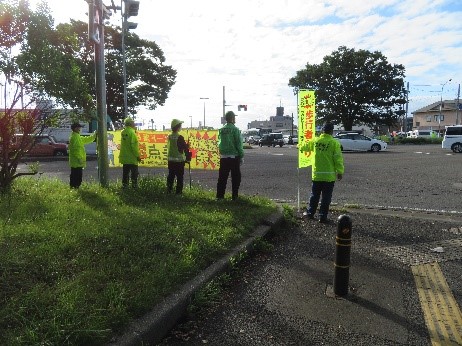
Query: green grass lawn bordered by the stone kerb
0,178,276,345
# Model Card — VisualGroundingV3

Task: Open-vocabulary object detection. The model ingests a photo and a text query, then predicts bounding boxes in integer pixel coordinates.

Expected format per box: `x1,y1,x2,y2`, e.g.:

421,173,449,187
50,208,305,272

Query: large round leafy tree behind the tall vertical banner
289,46,406,130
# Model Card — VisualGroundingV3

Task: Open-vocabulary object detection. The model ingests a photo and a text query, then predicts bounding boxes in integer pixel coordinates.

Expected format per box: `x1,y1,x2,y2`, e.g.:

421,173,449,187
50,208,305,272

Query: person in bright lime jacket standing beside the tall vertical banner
299,123,344,223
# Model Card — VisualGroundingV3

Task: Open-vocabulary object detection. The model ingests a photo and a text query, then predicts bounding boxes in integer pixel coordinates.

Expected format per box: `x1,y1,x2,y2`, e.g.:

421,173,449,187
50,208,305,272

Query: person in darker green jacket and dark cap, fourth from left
216,111,244,200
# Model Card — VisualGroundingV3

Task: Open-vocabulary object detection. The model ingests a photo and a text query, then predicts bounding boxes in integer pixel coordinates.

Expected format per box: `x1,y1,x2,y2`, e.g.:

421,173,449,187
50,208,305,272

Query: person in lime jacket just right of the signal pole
119,118,141,187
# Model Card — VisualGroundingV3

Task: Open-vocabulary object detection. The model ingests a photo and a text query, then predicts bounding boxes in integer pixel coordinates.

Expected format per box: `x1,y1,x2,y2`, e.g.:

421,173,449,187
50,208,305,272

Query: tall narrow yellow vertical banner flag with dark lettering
297,90,316,168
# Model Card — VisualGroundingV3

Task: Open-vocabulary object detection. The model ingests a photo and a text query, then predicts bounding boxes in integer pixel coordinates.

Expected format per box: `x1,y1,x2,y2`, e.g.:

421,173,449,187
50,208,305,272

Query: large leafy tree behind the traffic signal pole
21,20,176,120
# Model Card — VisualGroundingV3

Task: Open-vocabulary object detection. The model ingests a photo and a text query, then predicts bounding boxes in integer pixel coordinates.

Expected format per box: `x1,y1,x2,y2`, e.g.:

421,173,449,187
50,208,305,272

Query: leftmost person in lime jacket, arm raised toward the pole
68,123,96,189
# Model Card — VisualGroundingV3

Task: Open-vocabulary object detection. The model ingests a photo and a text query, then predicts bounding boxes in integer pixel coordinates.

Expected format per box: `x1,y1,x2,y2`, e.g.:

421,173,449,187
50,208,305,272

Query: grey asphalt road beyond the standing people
20,145,462,212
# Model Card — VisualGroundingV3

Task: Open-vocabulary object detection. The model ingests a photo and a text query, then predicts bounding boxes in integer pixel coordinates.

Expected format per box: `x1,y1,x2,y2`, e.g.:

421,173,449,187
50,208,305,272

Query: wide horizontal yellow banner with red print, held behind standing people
108,129,220,170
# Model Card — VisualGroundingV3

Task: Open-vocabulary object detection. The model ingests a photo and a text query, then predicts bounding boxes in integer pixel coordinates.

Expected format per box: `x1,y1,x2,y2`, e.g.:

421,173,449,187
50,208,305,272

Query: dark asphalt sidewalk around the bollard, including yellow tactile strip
114,209,462,346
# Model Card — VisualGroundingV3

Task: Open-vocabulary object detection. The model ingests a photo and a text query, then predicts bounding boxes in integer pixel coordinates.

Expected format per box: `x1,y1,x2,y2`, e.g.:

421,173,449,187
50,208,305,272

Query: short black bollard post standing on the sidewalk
334,215,352,297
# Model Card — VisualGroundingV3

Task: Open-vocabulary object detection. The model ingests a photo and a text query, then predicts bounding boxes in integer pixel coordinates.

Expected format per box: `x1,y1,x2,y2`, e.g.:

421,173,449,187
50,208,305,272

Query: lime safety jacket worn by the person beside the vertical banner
300,133,345,182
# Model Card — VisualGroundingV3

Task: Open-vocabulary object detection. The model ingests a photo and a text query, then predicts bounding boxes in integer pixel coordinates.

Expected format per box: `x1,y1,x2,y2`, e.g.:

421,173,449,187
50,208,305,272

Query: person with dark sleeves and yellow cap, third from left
167,119,189,195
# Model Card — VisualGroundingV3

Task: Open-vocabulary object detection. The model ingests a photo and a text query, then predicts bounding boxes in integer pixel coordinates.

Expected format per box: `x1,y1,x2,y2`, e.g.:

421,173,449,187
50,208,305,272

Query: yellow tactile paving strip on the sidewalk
411,263,462,346
